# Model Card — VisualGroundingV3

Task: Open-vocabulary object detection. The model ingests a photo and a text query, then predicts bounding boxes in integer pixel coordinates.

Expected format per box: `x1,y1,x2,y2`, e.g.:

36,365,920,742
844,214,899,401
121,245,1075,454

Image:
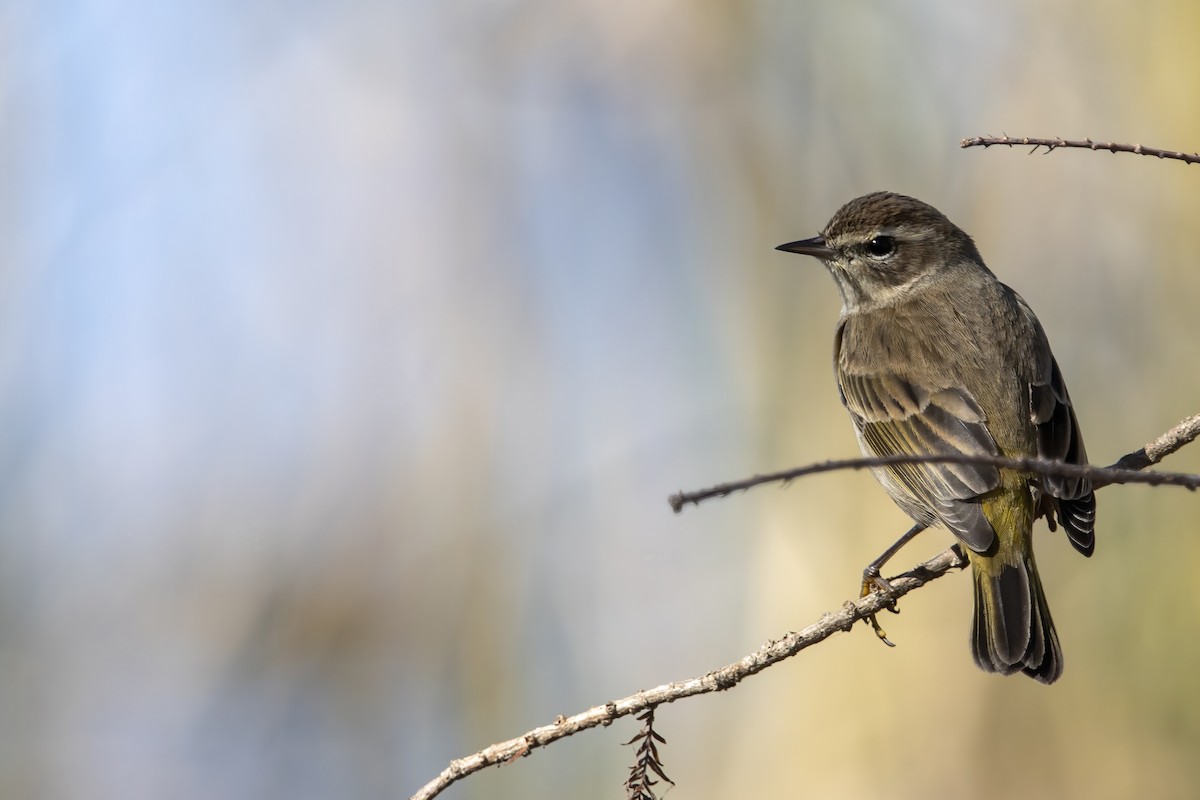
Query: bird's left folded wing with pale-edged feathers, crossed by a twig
838,371,1000,552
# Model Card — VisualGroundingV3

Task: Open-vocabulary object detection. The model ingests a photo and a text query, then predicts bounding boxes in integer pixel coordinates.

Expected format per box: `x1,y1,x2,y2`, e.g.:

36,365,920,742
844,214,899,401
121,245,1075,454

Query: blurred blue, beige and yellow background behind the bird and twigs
7,0,1200,799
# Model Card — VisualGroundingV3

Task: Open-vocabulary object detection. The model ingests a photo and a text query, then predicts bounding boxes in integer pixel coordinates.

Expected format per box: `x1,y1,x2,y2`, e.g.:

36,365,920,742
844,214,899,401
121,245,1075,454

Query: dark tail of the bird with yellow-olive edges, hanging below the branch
971,547,1062,684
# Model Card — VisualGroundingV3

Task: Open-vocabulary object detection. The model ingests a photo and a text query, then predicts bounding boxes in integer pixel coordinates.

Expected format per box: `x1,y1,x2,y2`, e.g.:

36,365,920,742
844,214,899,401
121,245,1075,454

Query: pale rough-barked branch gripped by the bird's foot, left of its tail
410,548,965,800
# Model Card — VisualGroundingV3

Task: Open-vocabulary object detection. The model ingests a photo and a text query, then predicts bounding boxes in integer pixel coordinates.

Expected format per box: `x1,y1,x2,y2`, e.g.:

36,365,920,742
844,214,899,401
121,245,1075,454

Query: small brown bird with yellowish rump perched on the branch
776,192,1096,684
